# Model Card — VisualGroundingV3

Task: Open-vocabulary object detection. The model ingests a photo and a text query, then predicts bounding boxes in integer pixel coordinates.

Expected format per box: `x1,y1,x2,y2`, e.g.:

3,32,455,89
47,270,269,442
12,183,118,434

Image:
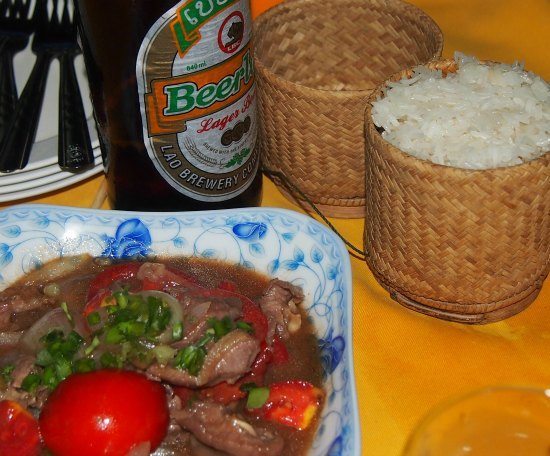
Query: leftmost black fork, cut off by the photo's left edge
0,0,33,139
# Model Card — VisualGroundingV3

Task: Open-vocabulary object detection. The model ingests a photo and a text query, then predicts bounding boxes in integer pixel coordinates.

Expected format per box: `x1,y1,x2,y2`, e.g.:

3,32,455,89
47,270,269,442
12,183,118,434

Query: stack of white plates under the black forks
0,34,103,202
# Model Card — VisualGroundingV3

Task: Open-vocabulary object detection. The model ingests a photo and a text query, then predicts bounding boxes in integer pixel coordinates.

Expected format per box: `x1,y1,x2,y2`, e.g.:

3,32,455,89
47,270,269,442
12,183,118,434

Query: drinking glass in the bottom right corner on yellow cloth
403,387,550,456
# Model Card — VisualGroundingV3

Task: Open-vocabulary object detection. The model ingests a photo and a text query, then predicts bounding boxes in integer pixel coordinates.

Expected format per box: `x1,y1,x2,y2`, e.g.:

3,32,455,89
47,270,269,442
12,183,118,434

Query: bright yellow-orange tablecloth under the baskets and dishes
0,0,550,456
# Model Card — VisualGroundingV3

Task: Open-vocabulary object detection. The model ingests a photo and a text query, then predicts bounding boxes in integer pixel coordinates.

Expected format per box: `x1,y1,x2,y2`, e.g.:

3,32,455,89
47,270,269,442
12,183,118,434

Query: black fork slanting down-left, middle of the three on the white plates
0,0,89,172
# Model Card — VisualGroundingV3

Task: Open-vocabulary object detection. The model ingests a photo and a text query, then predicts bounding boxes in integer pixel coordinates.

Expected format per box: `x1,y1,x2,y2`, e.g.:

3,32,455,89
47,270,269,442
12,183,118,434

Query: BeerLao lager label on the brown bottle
136,0,259,201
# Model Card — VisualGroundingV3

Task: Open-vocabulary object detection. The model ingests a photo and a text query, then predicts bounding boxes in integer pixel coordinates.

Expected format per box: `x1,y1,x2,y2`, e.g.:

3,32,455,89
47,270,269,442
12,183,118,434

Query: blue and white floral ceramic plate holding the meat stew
0,205,360,456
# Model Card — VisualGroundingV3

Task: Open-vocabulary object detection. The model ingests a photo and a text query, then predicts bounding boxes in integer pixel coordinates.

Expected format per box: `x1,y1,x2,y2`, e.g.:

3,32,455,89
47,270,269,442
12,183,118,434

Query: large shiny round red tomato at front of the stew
39,369,170,456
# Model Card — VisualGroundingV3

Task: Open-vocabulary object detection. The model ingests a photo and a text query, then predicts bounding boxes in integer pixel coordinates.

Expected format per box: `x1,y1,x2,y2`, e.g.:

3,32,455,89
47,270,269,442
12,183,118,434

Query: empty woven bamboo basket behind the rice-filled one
254,0,443,218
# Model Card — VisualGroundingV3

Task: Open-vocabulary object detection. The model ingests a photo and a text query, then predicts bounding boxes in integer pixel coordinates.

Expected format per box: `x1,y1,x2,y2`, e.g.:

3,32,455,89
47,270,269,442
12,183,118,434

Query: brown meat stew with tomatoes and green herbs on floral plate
0,256,324,456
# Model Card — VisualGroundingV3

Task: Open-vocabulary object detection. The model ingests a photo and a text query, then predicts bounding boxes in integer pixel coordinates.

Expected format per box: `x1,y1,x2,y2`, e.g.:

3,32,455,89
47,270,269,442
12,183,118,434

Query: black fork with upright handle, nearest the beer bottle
58,1,94,172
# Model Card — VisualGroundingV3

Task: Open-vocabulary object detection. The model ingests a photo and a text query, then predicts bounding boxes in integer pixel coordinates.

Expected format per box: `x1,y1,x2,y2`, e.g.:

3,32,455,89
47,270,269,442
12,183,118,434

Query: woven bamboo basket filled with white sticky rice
364,61,550,323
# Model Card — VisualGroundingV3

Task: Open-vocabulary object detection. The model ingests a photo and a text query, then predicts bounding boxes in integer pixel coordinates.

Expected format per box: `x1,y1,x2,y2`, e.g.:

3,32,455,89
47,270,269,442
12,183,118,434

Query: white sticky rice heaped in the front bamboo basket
372,53,550,169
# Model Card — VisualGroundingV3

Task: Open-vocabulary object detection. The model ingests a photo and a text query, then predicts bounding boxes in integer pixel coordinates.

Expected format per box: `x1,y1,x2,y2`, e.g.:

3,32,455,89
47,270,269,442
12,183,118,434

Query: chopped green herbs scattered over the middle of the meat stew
21,290,188,384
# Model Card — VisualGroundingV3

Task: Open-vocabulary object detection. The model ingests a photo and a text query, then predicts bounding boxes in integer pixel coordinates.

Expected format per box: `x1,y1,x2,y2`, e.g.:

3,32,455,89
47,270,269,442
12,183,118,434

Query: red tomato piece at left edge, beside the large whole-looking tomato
0,401,40,456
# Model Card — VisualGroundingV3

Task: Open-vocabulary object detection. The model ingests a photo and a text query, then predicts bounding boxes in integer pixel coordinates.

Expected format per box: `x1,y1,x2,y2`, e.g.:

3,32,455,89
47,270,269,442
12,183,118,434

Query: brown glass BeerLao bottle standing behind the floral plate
76,0,262,211
